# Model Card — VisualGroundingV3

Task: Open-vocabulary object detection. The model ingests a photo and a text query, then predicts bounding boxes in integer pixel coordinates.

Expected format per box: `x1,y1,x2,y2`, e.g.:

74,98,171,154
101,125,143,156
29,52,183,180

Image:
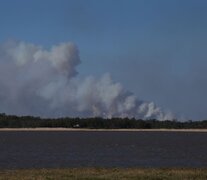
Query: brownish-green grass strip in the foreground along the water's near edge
0,168,207,180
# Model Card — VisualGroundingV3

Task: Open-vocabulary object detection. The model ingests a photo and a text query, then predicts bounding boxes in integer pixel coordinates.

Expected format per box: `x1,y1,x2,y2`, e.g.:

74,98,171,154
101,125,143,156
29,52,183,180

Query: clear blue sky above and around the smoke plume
0,0,207,120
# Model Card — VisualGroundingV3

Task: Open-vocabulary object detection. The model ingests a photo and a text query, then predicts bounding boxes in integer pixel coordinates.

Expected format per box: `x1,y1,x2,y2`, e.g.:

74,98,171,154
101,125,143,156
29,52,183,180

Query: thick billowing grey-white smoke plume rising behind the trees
0,42,172,120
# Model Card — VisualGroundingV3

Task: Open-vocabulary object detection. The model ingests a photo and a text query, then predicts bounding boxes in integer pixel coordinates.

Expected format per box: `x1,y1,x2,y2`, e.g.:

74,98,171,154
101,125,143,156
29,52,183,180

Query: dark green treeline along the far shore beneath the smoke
0,113,207,129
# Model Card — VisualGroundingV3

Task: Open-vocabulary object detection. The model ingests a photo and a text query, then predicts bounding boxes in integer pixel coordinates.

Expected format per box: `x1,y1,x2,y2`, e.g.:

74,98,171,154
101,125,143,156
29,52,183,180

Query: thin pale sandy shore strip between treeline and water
0,128,207,132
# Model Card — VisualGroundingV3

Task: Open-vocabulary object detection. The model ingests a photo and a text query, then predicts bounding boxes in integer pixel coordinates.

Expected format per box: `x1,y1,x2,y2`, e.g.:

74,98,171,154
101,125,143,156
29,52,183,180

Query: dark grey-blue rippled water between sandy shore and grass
0,131,207,169
